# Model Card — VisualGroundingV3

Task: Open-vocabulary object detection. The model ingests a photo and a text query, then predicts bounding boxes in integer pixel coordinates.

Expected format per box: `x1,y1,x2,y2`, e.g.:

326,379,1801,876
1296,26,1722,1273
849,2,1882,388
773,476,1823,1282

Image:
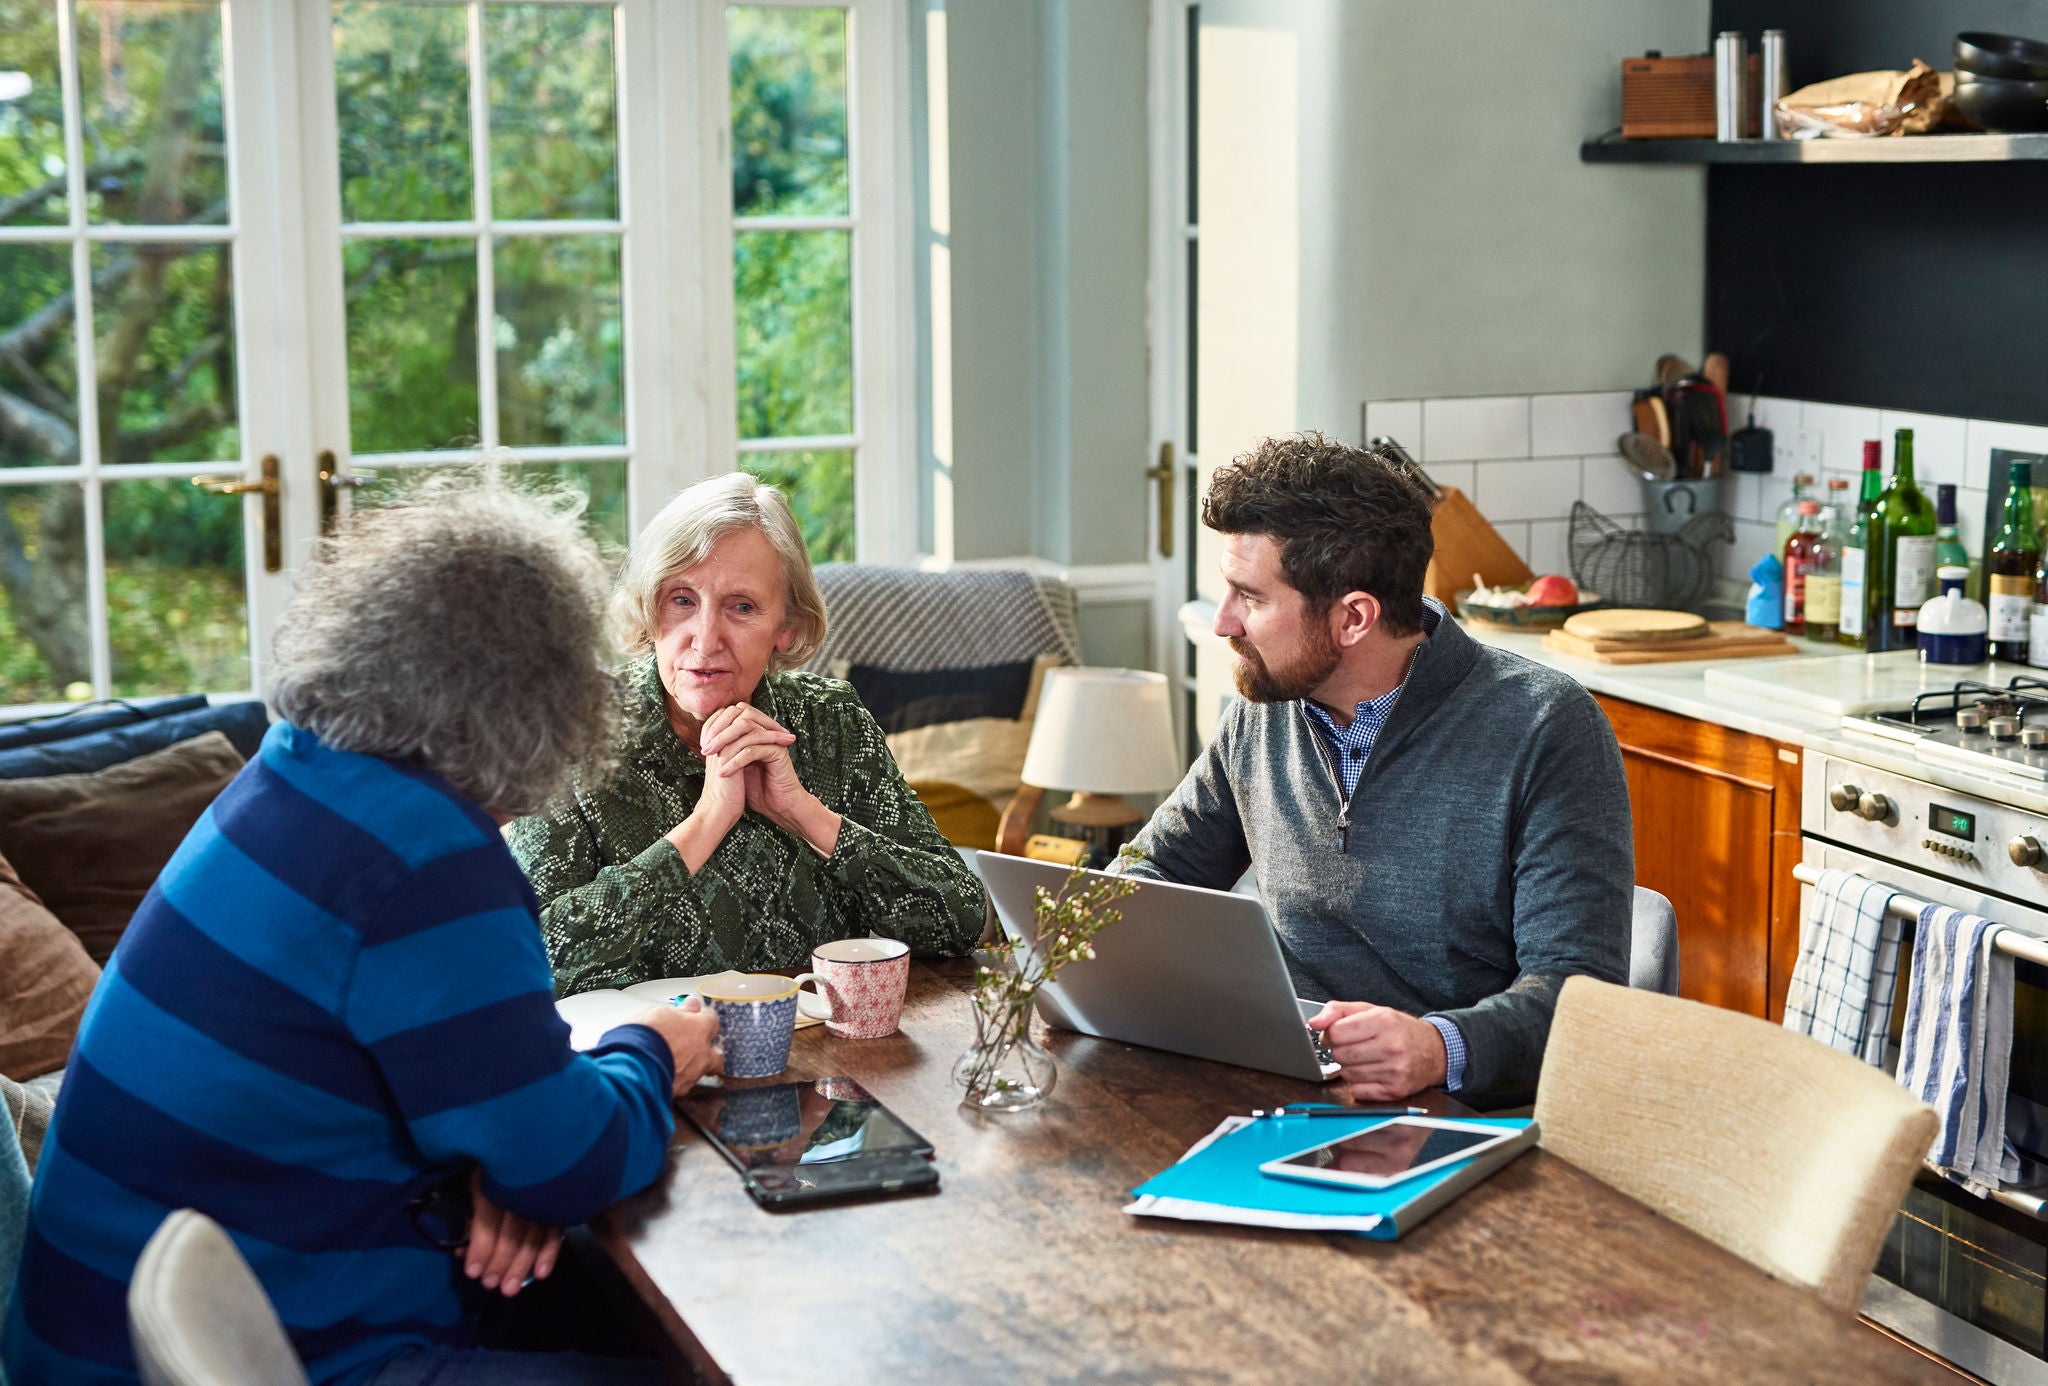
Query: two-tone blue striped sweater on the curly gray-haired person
0,723,674,1386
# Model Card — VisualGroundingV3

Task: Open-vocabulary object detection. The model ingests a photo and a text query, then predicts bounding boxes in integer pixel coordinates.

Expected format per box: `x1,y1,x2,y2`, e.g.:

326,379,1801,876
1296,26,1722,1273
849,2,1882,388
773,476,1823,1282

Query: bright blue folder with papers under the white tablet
1124,1116,1540,1241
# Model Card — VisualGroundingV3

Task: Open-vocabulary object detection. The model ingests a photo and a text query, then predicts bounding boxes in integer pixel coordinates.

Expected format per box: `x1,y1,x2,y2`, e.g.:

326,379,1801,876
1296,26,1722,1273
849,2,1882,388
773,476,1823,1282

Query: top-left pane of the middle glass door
334,0,475,221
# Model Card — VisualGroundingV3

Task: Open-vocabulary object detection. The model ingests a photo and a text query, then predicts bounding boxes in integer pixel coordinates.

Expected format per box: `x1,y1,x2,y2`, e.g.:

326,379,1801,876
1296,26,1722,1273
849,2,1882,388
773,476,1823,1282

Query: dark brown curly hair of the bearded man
1202,432,1436,635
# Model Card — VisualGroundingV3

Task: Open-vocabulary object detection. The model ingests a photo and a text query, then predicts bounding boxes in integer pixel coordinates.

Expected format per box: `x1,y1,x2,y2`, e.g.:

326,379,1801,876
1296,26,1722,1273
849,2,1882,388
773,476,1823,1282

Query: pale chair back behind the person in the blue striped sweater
129,1208,305,1386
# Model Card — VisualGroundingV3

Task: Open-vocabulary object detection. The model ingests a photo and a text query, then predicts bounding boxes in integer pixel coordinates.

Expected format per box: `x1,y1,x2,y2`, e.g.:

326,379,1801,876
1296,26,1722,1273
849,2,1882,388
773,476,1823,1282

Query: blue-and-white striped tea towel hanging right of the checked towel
1898,905,2019,1196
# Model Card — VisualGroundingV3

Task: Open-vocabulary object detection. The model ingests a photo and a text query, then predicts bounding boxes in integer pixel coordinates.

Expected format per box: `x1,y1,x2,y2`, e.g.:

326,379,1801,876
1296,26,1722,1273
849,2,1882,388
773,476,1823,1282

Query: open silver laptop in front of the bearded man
975,852,1337,1083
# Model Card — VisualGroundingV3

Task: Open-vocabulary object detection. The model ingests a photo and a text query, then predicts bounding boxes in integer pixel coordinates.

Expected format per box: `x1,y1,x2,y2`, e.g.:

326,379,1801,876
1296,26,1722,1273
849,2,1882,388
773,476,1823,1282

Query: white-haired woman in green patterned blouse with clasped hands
508,471,987,995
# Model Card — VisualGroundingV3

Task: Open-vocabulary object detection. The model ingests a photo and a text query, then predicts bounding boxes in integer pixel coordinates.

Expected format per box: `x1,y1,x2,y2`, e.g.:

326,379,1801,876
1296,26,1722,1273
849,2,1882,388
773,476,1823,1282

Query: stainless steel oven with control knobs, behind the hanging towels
1800,725,2048,1384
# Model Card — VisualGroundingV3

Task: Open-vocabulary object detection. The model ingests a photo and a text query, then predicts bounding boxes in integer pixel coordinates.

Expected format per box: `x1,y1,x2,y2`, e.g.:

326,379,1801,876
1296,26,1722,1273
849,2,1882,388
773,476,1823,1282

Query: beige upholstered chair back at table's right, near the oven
1536,977,1935,1312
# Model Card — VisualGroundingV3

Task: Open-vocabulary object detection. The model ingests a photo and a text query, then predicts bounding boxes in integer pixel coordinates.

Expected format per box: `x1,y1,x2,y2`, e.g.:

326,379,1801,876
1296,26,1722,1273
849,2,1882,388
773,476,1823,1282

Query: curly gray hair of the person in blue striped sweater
268,469,616,815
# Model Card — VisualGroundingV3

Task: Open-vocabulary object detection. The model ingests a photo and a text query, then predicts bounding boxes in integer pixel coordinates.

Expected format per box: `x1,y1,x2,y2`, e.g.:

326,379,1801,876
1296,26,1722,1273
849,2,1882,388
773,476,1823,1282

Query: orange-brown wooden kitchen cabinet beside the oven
1595,694,1800,1020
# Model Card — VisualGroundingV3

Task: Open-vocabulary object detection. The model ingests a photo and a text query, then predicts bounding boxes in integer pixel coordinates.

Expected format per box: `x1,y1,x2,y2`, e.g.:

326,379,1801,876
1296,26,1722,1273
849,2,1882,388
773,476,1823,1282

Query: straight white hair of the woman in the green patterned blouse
612,471,825,674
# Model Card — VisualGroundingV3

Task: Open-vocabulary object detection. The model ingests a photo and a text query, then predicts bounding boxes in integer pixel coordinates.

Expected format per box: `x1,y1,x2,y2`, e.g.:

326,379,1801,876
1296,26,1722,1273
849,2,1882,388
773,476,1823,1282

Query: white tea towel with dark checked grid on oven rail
1786,870,1903,1069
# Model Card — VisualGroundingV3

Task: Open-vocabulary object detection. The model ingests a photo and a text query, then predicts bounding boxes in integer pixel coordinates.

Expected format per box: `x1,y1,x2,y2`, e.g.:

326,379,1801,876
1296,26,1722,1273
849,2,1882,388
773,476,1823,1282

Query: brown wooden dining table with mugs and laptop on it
596,960,1958,1386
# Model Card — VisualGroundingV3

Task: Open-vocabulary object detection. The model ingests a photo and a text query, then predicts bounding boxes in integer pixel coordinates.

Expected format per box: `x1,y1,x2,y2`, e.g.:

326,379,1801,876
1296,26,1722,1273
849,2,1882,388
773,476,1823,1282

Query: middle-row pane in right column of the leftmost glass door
92,242,242,463
